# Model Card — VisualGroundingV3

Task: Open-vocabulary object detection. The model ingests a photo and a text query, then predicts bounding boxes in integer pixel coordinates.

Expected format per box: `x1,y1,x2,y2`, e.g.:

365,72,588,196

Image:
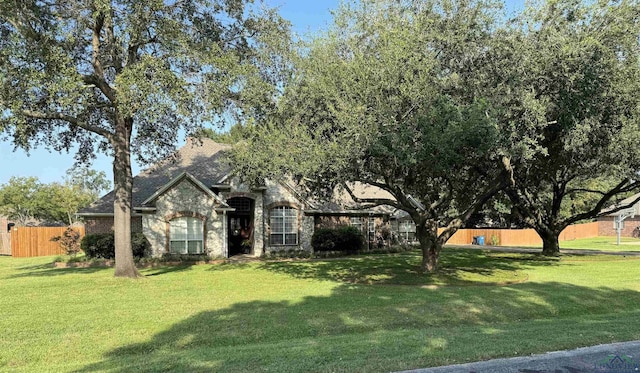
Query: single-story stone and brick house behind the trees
78,139,408,258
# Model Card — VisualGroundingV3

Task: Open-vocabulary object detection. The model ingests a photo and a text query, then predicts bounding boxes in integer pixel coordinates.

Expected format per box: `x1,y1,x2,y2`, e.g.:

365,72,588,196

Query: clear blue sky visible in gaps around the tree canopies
0,0,524,184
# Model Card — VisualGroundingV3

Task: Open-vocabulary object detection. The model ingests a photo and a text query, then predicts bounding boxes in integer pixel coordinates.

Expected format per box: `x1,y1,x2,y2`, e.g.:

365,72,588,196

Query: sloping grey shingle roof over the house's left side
80,139,231,215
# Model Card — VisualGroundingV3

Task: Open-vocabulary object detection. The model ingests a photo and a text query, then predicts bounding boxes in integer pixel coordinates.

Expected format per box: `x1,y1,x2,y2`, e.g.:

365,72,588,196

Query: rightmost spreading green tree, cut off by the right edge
494,1,640,253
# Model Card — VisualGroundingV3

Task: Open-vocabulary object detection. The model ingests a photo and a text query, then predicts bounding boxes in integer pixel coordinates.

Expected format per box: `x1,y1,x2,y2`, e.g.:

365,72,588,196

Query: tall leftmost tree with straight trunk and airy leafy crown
0,0,288,277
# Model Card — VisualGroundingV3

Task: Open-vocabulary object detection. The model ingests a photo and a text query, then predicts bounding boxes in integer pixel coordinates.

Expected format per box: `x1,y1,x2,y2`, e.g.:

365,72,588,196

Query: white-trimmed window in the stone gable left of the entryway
169,217,204,254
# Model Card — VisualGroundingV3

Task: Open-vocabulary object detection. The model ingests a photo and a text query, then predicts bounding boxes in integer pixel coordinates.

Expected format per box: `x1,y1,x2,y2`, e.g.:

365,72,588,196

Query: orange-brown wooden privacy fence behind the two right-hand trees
439,222,598,246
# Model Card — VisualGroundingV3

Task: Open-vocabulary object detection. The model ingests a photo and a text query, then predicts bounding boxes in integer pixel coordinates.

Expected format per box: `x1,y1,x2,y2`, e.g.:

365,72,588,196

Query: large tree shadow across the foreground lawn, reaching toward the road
78,283,640,372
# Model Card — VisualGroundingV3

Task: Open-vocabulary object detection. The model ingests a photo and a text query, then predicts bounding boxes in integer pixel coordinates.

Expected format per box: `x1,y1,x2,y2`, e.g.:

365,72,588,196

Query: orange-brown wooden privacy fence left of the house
11,227,84,258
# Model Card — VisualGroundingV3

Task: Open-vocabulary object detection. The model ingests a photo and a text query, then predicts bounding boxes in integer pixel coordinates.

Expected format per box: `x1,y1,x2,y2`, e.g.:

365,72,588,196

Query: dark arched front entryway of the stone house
227,197,255,257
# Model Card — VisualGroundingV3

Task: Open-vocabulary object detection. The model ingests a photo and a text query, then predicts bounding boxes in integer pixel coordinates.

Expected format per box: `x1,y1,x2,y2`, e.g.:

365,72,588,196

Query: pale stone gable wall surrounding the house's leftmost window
143,179,227,258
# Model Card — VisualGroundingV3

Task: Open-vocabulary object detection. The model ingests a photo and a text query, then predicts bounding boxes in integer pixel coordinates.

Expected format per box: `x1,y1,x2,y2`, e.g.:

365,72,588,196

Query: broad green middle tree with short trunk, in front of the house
234,1,505,270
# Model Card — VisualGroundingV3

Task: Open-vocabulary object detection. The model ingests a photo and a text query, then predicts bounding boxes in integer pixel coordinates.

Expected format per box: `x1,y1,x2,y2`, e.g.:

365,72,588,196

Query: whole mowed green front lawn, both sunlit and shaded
0,249,640,372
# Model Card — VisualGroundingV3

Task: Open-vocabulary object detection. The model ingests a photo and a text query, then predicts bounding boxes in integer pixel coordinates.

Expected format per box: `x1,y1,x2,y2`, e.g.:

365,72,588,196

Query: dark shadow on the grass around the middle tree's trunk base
255,250,558,286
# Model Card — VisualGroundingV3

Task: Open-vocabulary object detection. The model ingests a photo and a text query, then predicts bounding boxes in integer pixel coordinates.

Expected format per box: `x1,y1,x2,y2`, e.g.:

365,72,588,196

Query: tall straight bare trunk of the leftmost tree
112,114,140,278
